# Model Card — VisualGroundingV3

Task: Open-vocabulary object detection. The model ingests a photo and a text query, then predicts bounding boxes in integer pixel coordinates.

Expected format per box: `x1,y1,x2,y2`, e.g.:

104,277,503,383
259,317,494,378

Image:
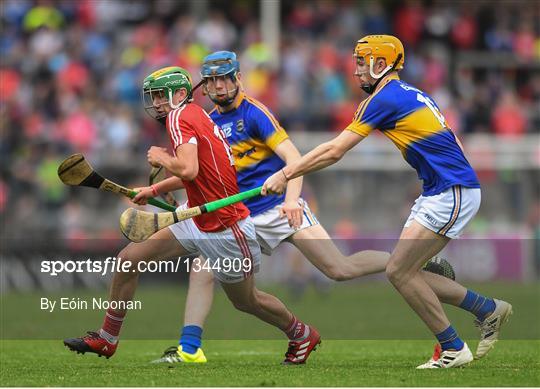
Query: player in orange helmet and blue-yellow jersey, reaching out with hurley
263,35,512,368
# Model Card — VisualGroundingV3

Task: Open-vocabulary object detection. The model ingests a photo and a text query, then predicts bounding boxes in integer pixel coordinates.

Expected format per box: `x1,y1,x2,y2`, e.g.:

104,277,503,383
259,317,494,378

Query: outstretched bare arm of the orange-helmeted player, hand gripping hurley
261,131,364,195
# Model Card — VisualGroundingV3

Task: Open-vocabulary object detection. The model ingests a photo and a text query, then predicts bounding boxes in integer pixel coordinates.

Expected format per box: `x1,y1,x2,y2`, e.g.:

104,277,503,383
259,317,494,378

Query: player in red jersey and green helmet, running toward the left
64,66,320,364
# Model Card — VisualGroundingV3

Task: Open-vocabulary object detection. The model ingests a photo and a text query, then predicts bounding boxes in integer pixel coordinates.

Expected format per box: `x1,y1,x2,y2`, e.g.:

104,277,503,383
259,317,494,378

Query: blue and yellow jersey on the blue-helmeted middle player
210,92,289,216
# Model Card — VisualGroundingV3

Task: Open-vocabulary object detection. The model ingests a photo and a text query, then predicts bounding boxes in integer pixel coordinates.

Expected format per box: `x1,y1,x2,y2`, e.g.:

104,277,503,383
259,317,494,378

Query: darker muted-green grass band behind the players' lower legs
0,282,540,340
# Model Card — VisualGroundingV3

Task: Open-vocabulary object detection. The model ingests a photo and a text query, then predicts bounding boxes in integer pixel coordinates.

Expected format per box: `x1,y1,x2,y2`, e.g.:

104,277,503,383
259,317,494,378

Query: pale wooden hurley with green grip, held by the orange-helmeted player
120,186,262,242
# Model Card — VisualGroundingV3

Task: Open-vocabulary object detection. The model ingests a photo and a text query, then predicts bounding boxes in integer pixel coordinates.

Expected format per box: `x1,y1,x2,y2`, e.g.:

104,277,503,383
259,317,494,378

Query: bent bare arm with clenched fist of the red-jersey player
148,143,199,181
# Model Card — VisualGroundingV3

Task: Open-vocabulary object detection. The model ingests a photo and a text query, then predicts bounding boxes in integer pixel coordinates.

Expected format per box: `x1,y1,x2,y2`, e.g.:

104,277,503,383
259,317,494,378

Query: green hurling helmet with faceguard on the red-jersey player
142,66,193,120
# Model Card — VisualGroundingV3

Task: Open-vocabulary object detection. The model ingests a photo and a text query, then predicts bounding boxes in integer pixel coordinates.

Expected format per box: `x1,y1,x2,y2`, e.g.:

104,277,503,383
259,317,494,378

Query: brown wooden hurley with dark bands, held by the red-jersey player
58,154,176,211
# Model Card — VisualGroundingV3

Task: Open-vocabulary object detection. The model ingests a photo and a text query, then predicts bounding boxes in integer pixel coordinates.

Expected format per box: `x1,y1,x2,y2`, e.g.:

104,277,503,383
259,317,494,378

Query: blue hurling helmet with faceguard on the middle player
201,51,240,106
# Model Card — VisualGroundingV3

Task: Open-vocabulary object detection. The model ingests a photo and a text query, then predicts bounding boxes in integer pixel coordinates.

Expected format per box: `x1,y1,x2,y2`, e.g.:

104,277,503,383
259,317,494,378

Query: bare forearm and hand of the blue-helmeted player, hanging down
274,139,304,228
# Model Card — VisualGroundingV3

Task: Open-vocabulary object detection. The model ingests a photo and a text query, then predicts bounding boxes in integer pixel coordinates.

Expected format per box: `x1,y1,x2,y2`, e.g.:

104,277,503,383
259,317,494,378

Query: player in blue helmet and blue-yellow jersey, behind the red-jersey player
153,51,460,364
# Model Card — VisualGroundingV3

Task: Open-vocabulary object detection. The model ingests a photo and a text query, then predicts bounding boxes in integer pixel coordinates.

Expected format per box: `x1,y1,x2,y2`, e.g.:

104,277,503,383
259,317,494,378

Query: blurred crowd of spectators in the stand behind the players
0,0,540,242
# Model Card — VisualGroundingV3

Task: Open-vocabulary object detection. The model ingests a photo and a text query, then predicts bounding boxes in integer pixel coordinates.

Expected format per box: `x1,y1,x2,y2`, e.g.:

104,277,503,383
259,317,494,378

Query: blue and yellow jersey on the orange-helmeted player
346,75,480,196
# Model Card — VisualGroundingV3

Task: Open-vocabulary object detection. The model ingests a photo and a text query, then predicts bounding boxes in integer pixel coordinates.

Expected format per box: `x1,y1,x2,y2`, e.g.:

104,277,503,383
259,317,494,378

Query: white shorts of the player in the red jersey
169,204,261,284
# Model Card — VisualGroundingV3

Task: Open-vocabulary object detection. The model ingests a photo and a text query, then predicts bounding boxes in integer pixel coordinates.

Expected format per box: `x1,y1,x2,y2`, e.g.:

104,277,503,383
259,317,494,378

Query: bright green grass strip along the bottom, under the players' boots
0,340,540,386
